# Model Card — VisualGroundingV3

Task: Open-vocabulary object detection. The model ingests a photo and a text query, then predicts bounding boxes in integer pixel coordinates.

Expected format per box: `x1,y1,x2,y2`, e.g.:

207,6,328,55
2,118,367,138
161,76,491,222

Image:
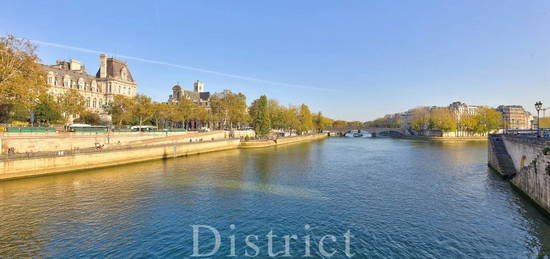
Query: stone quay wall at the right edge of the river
489,135,550,215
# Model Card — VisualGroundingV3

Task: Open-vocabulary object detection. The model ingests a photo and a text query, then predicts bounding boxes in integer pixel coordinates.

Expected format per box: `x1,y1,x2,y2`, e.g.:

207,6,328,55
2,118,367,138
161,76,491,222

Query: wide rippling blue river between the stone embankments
0,138,550,258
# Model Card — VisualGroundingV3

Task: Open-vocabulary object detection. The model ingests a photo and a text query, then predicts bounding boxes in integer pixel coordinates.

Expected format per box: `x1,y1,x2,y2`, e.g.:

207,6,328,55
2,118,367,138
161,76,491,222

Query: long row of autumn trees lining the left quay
0,36,354,138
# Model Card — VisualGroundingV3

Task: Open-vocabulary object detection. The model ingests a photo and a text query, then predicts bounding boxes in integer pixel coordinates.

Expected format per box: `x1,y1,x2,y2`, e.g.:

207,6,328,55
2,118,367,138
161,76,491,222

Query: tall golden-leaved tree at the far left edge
0,36,49,119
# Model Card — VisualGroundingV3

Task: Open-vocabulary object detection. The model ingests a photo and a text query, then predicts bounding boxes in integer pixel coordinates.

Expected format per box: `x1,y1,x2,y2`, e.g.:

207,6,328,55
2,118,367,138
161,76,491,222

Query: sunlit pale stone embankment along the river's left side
0,132,326,180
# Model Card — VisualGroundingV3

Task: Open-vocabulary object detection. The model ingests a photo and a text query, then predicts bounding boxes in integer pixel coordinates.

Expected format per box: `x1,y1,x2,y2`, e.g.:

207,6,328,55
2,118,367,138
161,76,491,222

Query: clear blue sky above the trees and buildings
0,0,550,121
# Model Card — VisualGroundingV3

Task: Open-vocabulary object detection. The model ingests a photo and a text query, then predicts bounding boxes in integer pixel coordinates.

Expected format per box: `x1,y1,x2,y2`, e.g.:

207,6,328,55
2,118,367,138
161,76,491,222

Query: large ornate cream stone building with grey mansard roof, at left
42,54,137,113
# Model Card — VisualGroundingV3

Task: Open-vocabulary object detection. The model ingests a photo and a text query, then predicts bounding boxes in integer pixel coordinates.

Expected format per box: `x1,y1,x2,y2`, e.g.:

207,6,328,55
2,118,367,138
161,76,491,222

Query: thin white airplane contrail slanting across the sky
27,39,332,91
